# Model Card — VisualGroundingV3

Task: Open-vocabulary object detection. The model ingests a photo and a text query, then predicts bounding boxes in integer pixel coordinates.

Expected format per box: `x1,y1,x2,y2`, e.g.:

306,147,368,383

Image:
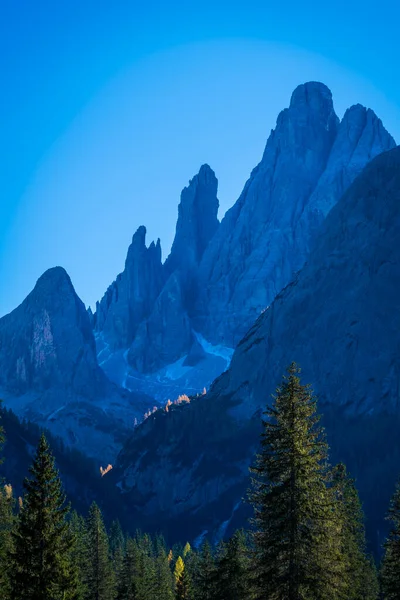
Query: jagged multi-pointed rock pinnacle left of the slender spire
95,226,164,350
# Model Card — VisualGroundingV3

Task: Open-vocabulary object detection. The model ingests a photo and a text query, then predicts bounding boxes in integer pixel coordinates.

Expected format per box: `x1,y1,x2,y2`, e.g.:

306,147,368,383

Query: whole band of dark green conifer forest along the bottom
0,364,400,600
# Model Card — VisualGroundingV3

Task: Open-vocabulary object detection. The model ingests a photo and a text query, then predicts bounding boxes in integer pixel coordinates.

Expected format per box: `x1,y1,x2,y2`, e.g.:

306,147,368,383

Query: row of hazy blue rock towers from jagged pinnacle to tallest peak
96,82,395,384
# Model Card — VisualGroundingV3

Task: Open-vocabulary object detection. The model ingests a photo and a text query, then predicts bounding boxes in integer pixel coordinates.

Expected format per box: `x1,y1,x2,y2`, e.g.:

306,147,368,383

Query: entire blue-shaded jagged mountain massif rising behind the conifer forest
0,82,400,539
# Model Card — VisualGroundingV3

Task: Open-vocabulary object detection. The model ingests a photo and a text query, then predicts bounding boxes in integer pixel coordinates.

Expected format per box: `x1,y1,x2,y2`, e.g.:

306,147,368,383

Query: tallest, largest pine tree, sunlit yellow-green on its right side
249,363,342,600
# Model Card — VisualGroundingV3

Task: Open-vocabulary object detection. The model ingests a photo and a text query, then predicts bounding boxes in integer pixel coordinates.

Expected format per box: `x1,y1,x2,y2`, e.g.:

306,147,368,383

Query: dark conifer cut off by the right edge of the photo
381,482,400,600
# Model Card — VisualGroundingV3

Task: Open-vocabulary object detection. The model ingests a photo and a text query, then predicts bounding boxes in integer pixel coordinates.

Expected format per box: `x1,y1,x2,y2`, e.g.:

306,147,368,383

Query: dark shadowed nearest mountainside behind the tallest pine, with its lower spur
116,148,400,548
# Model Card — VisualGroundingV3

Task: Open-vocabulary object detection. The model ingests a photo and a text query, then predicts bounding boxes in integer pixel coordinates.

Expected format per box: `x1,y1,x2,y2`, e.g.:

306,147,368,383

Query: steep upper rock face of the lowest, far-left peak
0,267,101,396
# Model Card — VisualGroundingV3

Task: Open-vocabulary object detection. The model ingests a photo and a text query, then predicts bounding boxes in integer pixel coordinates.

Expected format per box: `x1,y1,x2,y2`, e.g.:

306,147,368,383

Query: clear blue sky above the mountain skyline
0,0,400,314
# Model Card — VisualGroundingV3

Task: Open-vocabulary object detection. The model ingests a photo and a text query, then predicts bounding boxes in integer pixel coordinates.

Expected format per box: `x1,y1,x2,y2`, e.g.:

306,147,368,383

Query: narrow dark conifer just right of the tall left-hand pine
84,502,116,600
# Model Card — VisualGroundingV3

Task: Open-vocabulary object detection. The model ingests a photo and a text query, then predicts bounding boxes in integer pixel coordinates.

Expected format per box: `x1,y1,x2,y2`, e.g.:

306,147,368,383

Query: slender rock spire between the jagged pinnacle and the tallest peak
165,164,219,274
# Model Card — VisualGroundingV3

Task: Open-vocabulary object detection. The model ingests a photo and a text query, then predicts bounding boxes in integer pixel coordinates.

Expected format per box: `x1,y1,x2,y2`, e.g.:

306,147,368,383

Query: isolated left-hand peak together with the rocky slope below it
0,267,153,459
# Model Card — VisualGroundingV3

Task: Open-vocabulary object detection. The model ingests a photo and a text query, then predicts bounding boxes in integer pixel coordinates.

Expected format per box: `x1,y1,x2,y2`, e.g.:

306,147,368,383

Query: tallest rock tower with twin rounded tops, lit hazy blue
195,83,395,347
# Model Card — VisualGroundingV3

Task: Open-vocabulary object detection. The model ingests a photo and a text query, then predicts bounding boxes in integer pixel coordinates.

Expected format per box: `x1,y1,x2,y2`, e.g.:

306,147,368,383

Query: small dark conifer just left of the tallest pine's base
215,531,252,600
